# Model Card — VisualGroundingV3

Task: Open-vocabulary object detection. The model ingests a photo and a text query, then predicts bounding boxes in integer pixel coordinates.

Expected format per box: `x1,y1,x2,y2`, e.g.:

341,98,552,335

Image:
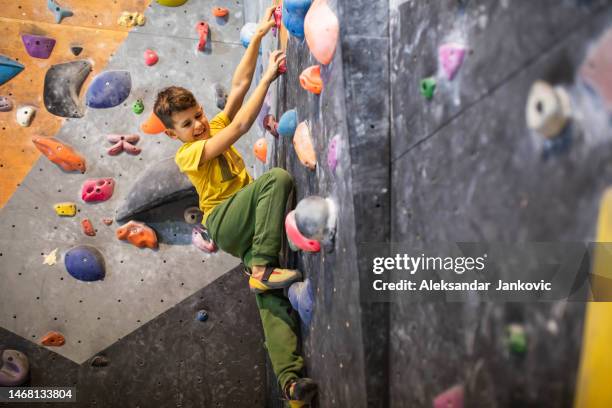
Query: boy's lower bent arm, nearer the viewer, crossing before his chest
200,50,285,165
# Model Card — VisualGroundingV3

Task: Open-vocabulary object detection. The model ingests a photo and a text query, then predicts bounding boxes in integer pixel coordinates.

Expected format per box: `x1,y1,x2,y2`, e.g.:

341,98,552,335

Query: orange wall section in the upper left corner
0,0,150,208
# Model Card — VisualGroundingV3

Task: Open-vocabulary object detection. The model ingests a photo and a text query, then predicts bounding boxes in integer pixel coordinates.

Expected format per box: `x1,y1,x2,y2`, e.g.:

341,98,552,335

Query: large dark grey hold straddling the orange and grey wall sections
43,60,91,118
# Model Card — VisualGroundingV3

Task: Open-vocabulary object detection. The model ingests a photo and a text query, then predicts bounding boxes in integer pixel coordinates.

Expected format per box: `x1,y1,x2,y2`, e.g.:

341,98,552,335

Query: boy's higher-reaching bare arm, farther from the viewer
223,6,276,120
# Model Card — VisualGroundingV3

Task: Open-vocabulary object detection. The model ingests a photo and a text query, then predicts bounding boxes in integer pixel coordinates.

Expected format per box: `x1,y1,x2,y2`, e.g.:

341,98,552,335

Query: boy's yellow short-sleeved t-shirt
174,111,253,224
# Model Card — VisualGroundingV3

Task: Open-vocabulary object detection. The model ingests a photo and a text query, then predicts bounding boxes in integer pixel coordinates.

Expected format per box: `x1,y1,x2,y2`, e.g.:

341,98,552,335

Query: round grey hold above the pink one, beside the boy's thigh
295,196,337,247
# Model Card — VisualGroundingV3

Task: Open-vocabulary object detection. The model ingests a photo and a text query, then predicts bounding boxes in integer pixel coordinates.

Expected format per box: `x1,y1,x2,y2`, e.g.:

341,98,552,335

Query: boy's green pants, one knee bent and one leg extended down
206,168,304,390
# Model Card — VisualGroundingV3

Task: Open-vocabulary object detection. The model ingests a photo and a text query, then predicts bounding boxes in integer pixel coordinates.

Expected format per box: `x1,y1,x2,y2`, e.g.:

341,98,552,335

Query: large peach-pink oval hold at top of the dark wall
304,0,340,65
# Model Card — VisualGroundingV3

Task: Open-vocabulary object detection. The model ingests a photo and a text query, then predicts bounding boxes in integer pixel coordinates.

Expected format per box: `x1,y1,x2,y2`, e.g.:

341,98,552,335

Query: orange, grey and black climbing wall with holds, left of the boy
0,0,266,406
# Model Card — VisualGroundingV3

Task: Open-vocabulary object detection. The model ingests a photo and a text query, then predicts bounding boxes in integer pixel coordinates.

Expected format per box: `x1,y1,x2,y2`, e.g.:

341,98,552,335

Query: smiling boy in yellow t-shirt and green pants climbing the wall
154,6,316,407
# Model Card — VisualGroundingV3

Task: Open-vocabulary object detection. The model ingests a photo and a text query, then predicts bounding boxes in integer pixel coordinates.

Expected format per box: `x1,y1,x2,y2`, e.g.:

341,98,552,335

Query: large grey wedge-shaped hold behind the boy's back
116,157,195,221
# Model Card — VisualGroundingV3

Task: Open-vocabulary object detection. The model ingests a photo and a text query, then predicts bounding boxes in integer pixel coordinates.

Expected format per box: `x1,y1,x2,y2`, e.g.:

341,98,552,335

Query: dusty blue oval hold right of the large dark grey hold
86,71,132,109
